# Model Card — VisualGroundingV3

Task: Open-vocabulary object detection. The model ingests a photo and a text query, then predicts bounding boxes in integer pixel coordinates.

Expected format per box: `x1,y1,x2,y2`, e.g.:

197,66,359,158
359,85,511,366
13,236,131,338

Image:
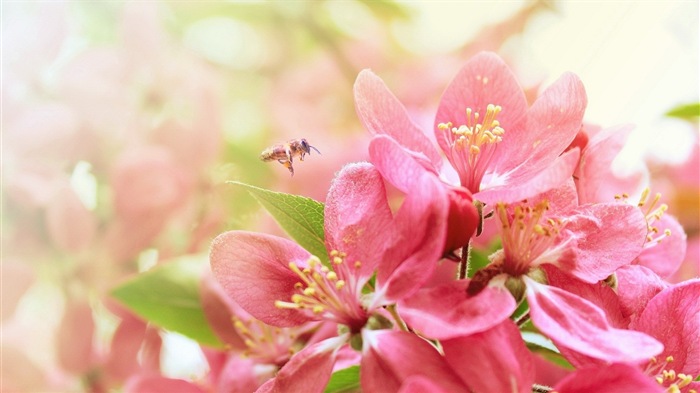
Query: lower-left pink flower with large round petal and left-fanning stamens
210,164,449,391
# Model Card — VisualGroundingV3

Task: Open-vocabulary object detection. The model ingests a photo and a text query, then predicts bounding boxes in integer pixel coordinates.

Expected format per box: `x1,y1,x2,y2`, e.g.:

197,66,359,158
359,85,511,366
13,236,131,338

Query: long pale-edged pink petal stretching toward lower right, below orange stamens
523,276,663,364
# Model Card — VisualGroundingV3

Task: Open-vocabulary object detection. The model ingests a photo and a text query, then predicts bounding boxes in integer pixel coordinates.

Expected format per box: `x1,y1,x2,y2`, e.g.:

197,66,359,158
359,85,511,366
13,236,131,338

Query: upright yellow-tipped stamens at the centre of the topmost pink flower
438,104,505,192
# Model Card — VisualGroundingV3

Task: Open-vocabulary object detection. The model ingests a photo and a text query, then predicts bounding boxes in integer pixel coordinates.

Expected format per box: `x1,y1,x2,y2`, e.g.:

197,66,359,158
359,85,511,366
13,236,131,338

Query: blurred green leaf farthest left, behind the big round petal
111,255,224,348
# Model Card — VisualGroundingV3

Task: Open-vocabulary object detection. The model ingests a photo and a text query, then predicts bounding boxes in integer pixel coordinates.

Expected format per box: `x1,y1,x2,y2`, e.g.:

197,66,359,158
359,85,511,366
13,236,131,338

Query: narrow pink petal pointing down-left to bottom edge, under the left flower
258,335,347,393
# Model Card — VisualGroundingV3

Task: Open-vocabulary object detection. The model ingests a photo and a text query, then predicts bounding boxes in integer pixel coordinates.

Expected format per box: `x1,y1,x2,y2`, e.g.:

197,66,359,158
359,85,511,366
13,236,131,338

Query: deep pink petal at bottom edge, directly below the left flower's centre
360,329,466,393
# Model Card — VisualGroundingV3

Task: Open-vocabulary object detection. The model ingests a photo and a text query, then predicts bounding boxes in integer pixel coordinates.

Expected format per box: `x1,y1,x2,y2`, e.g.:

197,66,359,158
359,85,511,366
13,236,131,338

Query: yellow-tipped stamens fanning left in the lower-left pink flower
275,250,367,331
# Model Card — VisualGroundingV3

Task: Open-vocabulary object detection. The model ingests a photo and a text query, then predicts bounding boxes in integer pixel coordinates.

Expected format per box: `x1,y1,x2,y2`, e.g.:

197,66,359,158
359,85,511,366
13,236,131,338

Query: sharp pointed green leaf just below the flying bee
228,181,328,263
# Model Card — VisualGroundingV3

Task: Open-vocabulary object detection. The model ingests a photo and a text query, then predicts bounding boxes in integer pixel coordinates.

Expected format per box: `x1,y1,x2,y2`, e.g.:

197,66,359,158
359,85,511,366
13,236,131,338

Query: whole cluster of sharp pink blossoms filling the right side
210,53,700,393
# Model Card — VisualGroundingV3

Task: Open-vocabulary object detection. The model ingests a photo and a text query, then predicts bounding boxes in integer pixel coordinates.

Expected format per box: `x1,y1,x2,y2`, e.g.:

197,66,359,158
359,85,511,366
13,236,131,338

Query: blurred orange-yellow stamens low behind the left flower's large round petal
233,317,298,365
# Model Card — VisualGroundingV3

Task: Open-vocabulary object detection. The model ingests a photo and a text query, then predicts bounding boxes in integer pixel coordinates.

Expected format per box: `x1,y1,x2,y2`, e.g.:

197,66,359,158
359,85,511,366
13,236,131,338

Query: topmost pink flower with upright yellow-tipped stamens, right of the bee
355,53,586,203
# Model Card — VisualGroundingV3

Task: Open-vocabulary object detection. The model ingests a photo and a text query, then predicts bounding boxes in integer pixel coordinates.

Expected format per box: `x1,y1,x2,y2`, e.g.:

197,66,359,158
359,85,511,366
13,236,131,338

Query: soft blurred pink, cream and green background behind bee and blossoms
1,0,700,391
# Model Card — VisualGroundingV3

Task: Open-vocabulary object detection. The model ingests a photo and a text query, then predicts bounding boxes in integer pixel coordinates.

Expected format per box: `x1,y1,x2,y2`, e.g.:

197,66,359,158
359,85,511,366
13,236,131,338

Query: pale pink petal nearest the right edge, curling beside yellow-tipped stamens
635,214,688,278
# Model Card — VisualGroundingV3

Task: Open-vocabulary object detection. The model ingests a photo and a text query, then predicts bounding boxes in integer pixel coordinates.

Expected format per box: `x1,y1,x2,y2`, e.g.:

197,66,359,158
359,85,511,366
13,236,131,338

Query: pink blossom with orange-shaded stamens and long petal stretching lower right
468,185,662,363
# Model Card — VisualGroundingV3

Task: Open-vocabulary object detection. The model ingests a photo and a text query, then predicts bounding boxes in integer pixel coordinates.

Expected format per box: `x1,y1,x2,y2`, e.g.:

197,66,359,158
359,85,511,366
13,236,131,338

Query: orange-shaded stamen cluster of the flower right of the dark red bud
496,200,565,277
